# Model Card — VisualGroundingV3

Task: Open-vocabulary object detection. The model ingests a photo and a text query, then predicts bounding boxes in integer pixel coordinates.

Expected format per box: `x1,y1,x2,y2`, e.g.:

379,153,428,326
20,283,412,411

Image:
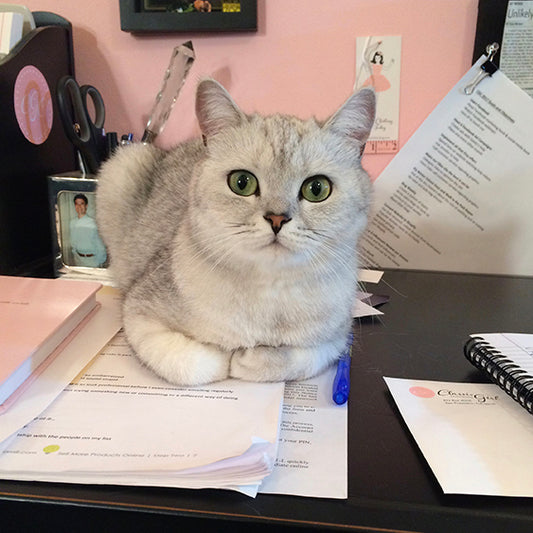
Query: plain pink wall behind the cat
24,0,477,178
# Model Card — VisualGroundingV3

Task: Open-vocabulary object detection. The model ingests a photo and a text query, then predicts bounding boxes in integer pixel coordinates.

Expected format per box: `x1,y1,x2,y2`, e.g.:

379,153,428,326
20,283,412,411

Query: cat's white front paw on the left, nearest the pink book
124,314,231,385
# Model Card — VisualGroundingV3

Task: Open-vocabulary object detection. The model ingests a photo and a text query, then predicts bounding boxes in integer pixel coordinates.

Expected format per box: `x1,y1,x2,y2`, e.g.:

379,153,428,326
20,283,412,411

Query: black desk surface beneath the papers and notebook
0,271,533,533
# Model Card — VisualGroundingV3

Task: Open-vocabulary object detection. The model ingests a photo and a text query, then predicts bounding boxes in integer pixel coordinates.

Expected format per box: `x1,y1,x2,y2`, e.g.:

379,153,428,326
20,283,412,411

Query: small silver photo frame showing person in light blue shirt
48,173,109,278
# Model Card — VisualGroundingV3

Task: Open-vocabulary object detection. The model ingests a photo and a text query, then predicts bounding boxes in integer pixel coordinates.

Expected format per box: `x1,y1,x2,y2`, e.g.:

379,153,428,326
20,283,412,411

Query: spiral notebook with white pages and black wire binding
464,333,533,414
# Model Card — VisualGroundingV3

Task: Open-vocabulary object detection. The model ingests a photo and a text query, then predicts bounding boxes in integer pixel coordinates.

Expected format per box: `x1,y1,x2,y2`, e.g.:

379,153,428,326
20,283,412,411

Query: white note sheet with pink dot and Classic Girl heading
385,378,533,497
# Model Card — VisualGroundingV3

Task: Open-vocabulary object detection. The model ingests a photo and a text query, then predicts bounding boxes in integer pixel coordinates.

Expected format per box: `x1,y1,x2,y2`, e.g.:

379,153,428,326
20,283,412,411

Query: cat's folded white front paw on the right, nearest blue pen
230,344,339,381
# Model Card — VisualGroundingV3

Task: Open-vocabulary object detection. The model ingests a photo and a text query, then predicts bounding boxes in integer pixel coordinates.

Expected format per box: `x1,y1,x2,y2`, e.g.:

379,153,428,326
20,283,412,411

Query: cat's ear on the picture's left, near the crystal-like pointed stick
196,79,245,139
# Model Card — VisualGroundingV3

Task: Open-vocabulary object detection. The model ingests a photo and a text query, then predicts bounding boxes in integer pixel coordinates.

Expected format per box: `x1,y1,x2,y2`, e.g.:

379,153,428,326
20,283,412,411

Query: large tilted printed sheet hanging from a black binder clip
360,59,533,275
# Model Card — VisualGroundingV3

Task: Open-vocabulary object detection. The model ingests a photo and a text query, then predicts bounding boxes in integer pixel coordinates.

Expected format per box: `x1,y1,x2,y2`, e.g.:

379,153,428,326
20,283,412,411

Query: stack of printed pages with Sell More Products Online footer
0,333,284,494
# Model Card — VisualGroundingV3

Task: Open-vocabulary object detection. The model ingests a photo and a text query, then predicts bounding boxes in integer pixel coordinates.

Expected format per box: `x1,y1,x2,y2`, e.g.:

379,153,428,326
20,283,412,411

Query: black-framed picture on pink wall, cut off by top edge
120,0,257,33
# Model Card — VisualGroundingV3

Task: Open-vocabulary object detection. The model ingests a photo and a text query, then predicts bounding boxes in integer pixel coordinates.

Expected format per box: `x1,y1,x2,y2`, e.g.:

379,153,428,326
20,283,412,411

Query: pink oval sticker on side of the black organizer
13,65,54,144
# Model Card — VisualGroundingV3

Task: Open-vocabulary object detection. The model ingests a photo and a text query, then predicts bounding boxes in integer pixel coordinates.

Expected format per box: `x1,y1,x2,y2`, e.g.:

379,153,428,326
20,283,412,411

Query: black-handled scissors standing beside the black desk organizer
57,76,107,174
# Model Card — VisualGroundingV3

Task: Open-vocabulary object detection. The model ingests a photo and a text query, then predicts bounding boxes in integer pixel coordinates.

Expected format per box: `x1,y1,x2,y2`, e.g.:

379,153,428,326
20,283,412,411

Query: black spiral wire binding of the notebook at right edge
464,337,533,414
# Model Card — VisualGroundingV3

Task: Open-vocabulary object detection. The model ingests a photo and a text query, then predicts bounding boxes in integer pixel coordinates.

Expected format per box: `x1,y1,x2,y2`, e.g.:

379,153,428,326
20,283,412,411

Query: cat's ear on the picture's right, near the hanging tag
324,87,376,151
